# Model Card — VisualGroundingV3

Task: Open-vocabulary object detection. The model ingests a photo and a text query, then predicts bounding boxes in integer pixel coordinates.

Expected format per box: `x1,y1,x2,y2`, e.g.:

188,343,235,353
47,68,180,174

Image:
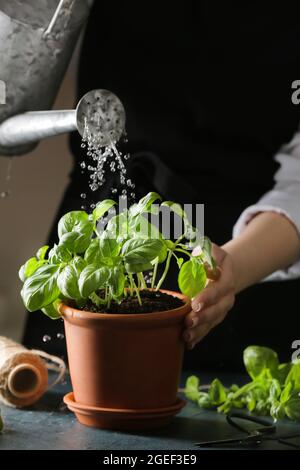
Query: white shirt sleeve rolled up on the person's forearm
233,128,300,281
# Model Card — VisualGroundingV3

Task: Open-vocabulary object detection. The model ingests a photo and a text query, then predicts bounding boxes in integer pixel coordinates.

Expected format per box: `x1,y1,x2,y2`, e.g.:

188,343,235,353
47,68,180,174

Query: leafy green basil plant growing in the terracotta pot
19,192,215,319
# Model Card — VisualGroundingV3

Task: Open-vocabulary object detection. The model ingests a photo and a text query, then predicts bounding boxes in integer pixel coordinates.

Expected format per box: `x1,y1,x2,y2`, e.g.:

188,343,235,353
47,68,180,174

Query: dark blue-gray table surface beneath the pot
0,374,300,451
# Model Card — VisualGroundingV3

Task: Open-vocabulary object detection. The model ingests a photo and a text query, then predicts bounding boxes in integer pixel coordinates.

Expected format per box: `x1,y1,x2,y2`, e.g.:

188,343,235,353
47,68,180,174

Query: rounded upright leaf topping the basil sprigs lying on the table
244,346,278,379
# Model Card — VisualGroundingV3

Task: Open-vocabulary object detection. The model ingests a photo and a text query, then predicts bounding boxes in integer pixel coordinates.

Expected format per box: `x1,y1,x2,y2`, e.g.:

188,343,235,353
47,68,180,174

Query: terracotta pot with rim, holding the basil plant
61,291,191,428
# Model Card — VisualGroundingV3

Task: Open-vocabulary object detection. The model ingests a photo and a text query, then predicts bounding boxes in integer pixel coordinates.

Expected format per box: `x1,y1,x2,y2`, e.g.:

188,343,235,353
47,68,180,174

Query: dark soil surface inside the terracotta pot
82,290,184,313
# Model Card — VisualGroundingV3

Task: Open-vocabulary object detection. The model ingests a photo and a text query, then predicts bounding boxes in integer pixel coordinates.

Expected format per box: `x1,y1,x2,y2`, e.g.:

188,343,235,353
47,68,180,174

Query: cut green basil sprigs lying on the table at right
184,346,300,421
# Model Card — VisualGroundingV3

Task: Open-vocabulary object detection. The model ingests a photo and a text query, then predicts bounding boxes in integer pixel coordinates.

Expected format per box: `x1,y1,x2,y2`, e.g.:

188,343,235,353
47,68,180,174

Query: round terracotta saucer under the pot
64,392,186,431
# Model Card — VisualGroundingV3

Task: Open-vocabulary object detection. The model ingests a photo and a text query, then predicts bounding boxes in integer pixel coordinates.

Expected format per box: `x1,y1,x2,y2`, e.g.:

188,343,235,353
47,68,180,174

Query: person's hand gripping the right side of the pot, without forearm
183,244,235,349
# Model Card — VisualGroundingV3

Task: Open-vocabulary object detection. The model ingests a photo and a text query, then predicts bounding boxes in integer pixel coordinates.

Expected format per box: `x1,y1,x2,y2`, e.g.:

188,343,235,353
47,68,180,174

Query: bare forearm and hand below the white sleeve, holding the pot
183,212,300,349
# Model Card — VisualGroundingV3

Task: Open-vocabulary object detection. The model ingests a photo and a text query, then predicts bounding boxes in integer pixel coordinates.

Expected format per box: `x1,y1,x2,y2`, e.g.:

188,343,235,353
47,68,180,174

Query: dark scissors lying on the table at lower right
195,411,300,449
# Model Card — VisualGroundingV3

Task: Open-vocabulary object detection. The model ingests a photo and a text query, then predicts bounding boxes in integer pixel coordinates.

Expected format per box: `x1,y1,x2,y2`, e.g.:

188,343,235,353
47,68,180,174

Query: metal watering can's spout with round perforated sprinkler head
0,90,125,155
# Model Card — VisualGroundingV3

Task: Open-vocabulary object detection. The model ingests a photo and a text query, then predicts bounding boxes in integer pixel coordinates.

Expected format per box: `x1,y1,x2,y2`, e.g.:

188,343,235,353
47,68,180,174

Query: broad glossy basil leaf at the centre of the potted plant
122,238,163,265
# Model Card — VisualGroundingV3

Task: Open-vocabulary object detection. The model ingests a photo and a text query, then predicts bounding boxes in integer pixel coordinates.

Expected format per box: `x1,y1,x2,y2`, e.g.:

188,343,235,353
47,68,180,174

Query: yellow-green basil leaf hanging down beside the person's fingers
178,258,206,299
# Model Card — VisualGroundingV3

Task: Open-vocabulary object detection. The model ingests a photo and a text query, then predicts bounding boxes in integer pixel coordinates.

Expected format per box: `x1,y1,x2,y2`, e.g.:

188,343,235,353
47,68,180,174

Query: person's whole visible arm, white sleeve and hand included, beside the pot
183,125,300,348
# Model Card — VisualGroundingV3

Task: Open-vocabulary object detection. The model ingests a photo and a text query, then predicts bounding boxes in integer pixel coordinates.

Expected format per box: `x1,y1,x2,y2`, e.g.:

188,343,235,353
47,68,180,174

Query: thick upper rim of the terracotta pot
59,289,191,326
